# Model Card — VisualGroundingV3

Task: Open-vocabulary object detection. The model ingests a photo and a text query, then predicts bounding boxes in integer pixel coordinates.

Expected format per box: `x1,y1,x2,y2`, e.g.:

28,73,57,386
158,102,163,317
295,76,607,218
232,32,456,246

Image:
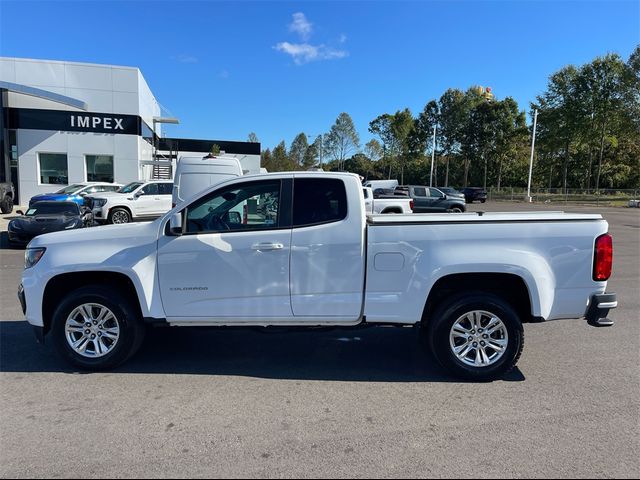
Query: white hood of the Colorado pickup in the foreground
29,220,159,248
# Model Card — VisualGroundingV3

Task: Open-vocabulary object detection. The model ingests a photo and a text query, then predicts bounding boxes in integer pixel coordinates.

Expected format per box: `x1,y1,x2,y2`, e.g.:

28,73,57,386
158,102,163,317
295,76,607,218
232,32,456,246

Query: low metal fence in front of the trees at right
487,187,640,205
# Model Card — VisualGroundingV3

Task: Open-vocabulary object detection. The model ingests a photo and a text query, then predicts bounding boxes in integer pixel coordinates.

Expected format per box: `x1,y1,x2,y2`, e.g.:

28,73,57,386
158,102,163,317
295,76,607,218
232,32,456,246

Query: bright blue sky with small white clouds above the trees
0,0,640,148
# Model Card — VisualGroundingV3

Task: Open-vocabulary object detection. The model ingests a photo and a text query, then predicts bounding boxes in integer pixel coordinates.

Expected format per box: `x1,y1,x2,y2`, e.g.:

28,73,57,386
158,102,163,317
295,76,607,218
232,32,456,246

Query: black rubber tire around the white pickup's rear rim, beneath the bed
425,292,524,381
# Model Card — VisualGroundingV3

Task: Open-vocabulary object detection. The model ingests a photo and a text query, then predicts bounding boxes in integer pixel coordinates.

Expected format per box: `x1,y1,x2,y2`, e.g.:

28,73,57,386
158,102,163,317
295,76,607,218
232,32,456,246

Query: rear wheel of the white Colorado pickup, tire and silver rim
427,292,524,381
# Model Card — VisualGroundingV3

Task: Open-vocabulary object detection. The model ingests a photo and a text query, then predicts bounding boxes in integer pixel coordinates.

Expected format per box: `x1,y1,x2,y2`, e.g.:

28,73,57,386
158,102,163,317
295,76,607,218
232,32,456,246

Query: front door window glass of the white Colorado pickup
185,180,281,233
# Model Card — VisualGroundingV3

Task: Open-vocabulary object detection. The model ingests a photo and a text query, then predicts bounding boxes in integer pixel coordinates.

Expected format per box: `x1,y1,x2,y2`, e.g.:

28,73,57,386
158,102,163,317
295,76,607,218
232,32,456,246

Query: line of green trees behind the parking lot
250,46,640,191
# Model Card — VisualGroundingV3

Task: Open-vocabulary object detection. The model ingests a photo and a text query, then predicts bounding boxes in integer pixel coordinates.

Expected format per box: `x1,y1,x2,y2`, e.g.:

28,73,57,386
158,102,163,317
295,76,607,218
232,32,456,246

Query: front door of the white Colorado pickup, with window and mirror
158,179,293,323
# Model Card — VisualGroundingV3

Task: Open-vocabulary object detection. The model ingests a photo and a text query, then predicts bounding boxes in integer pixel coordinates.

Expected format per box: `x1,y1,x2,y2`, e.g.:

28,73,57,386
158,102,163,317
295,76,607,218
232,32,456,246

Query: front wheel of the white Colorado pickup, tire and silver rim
51,285,145,371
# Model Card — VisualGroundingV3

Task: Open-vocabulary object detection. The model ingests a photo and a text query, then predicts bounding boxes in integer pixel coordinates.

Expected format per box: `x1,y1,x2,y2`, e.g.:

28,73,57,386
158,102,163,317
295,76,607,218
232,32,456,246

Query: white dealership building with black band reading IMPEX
0,57,260,204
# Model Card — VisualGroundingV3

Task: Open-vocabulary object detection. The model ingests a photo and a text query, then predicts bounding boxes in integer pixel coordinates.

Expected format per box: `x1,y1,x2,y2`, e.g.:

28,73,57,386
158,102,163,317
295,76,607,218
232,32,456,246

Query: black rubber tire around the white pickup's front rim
51,285,146,371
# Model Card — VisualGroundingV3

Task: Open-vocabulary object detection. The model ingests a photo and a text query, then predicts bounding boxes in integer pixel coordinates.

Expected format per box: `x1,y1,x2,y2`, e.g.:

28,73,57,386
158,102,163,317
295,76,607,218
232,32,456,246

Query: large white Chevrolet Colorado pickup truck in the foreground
18,172,617,380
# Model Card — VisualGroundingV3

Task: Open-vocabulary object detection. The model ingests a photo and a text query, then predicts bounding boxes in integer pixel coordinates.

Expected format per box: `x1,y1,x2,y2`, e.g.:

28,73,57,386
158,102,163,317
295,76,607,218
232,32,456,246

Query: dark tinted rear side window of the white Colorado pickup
293,178,347,227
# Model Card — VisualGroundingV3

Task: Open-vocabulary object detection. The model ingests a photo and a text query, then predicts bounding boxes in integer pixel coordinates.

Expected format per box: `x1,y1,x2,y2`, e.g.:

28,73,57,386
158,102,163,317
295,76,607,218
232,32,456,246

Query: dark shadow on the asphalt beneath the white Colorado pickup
0,322,525,382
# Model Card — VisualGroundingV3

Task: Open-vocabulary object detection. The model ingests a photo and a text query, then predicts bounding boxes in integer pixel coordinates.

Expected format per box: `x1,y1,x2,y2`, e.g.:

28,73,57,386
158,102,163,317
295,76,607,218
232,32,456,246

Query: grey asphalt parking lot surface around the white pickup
0,203,640,478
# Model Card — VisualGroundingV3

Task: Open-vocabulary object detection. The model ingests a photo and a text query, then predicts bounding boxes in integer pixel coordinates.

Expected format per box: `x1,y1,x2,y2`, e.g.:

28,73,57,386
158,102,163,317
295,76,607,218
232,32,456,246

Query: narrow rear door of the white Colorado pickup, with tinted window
291,176,365,322
